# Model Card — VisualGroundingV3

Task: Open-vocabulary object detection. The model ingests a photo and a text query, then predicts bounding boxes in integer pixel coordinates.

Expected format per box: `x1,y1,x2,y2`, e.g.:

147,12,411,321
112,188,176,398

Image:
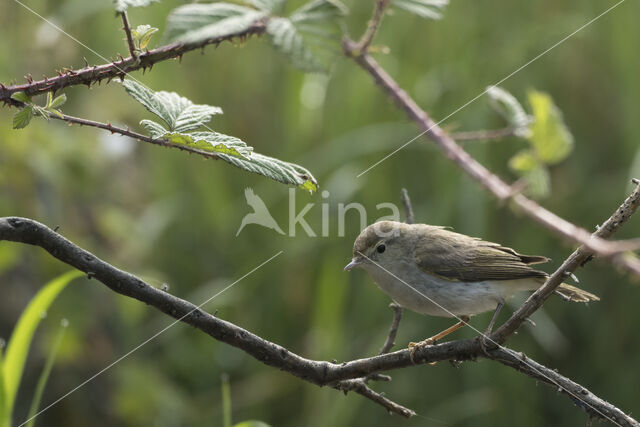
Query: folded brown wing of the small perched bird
415,227,548,282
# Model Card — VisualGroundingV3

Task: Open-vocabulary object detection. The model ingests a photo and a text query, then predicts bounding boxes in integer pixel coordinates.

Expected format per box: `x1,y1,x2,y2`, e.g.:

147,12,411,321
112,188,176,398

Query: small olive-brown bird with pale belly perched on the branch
344,221,600,359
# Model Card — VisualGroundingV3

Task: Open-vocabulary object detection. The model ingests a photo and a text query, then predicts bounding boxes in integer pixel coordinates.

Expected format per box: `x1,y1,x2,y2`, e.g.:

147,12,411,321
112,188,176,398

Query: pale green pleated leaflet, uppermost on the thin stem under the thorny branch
122,80,222,132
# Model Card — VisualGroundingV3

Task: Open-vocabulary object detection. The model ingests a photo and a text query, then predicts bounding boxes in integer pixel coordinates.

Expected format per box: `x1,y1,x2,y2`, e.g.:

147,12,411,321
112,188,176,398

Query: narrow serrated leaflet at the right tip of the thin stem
219,153,318,191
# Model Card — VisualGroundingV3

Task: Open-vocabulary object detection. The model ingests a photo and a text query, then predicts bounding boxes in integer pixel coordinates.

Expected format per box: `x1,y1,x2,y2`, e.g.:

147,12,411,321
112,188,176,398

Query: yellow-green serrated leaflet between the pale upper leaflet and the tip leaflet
161,132,253,157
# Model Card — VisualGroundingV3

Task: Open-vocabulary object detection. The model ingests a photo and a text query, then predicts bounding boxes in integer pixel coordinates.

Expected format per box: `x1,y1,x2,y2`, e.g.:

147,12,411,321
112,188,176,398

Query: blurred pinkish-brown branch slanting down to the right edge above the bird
343,39,640,275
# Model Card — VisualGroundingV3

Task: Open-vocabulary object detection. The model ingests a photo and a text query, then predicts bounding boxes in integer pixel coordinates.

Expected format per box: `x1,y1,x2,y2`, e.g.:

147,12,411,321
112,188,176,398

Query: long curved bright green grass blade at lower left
3,270,83,419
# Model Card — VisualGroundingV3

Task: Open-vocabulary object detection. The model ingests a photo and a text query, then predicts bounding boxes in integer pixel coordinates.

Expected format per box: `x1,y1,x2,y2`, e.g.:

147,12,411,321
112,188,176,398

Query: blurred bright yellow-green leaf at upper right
528,90,573,164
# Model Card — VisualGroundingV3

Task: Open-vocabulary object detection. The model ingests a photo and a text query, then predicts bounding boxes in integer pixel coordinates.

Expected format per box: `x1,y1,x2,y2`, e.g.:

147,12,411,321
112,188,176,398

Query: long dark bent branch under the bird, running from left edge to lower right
0,217,640,427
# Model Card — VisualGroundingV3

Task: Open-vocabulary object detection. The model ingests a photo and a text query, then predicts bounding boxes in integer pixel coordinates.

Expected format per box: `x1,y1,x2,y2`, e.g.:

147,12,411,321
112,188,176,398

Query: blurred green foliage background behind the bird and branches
0,0,640,426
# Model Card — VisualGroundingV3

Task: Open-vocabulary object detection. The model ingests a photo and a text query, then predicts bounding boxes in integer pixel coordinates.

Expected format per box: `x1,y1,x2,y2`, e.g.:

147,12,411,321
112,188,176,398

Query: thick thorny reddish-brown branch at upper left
0,20,266,105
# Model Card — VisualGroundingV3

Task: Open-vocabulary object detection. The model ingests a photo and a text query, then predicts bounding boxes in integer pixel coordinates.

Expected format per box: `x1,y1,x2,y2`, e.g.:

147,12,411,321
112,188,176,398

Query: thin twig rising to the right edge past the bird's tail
491,180,640,344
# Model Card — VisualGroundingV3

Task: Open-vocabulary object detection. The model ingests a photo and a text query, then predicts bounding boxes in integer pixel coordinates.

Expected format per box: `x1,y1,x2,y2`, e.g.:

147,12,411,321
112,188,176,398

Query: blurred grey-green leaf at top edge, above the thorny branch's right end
165,3,268,44
